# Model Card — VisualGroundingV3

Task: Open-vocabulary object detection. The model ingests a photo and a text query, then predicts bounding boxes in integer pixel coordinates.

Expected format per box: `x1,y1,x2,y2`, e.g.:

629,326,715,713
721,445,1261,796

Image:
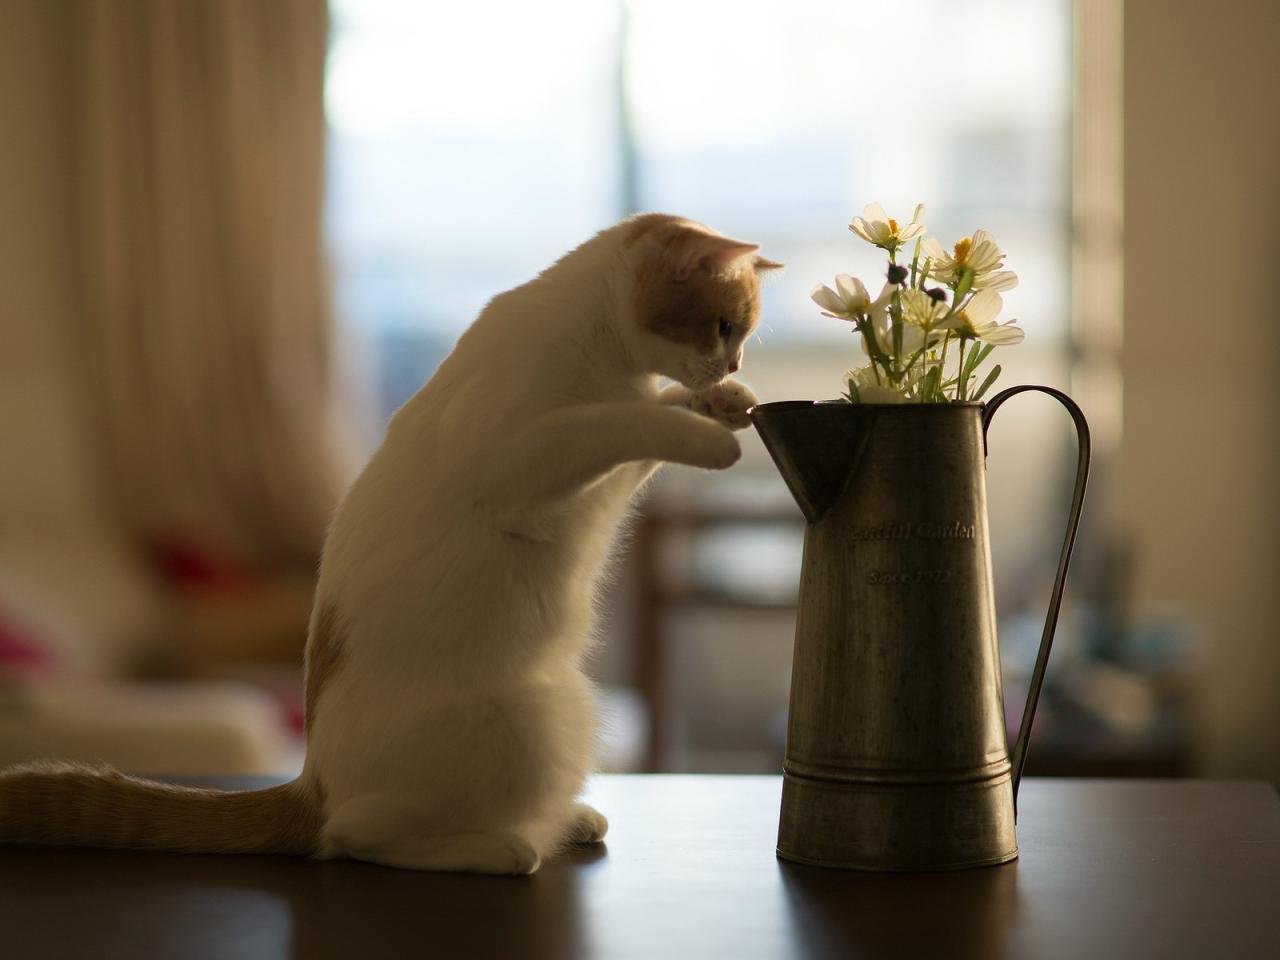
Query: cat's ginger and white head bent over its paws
622,214,781,389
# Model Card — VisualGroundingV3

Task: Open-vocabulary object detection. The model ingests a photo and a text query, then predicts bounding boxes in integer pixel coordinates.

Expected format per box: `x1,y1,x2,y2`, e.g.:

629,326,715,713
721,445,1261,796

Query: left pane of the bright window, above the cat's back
325,0,620,419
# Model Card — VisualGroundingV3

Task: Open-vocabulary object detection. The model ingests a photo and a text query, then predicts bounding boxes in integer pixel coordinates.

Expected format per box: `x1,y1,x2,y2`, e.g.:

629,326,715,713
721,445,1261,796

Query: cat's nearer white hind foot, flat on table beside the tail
323,796,541,876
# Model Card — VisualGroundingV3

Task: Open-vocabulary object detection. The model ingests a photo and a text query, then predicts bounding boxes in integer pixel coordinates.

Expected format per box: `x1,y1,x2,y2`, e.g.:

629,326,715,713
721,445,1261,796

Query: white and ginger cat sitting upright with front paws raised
0,214,778,874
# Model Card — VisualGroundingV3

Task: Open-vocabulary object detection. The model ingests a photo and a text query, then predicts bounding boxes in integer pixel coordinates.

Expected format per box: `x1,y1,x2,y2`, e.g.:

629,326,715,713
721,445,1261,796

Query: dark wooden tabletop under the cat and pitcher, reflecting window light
0,776,1280,960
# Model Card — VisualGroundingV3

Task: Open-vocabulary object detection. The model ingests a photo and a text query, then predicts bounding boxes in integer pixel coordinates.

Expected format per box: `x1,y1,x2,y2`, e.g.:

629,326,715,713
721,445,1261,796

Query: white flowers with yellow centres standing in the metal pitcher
812,204,1024,403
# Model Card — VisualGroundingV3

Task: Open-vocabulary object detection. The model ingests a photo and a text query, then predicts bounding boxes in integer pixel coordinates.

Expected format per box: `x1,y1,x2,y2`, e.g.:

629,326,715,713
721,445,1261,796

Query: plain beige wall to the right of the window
1121,0,1280,781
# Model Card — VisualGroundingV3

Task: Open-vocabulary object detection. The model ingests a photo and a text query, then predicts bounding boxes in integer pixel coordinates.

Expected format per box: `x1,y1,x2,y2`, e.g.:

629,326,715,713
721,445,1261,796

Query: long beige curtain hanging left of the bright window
77,0,344,567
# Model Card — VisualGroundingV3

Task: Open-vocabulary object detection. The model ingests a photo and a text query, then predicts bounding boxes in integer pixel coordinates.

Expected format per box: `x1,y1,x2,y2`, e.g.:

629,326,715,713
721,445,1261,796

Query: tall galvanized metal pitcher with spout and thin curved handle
750,387,1089,870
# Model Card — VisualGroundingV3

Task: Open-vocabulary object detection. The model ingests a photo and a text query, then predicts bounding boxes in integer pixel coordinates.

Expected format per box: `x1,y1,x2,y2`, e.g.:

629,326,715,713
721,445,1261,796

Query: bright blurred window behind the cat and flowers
326,0,1071,416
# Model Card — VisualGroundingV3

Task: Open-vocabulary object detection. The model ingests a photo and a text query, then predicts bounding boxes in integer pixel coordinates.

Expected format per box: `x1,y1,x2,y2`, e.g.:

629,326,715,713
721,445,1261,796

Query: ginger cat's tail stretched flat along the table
0,763,323,855
